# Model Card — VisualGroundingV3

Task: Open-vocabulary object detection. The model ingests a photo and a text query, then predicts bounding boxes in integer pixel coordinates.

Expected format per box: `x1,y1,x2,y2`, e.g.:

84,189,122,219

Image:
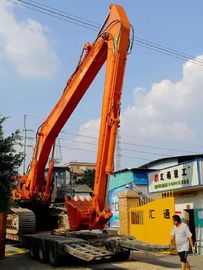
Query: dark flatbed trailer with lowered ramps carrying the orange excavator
14,231,171,266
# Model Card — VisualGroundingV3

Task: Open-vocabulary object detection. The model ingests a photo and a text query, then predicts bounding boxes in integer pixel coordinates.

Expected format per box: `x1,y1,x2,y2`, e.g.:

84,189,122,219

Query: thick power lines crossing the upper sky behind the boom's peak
5,0,203,66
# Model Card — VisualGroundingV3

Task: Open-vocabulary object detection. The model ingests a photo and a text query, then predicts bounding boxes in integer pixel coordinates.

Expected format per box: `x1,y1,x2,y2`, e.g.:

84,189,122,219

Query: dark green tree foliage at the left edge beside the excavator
0,117,24,212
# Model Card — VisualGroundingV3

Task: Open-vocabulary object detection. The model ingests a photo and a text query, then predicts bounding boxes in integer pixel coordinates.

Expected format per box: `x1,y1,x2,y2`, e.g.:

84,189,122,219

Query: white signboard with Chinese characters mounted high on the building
148,160,199,193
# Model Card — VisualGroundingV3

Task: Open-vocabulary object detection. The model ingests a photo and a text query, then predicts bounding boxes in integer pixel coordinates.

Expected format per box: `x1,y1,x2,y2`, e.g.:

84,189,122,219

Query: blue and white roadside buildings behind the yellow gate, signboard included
108,154,203,254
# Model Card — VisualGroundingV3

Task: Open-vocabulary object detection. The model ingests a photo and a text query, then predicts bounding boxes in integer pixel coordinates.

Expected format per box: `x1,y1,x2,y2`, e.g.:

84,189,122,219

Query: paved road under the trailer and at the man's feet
0,247,203,270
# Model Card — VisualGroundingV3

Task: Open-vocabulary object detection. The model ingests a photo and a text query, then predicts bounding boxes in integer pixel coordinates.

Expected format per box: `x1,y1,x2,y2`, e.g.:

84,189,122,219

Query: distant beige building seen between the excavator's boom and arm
64,161,96,183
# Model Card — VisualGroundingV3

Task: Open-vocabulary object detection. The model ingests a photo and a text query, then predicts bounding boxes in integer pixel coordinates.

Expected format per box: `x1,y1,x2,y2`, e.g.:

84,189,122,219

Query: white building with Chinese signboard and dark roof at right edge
141,155,203,254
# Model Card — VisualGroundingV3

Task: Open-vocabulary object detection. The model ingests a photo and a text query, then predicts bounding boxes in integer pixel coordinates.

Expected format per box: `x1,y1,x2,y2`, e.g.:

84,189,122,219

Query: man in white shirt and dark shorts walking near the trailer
171,215,195,270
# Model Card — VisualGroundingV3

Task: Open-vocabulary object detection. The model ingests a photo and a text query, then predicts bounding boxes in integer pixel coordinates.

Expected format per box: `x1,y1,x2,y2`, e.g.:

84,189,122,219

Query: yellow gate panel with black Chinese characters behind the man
129,197,175,245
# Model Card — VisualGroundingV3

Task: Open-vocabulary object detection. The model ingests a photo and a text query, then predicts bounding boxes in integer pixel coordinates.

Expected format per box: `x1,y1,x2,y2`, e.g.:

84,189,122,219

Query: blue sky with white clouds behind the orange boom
0,0,203,172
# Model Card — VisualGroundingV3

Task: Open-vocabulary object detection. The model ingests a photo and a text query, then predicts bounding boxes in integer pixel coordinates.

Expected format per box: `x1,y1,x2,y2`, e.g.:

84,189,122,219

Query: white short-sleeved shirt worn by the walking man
171,223,192,252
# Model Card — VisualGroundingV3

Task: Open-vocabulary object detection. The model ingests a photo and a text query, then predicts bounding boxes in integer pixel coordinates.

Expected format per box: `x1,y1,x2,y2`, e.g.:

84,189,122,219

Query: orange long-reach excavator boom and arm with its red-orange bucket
13,4,130,230
